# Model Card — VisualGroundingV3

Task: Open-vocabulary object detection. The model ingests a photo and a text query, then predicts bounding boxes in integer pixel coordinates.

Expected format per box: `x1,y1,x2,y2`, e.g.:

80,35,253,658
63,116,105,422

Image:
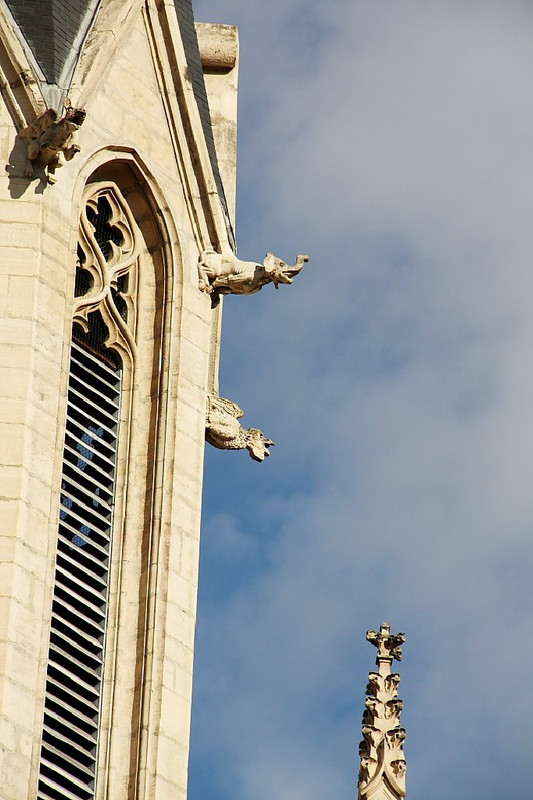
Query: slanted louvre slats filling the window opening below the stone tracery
38,326,122,800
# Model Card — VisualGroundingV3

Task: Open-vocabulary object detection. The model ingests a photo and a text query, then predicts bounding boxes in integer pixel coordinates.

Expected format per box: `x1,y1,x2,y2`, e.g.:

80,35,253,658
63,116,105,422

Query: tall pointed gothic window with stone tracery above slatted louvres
38,183,138,800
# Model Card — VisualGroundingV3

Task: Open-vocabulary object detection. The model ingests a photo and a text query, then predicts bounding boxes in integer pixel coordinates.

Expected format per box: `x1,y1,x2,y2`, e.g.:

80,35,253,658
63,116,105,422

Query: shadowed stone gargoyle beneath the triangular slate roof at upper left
18,105,85,183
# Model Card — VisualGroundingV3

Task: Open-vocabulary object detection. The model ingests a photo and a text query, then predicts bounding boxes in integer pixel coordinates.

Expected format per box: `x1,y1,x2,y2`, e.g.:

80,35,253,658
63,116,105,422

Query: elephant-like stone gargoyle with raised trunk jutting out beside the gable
198,250,309,302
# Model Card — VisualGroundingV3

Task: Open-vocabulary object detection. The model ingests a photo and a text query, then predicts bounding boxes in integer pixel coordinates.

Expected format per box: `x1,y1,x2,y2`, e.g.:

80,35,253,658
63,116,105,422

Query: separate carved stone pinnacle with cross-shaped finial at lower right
358,622,406,800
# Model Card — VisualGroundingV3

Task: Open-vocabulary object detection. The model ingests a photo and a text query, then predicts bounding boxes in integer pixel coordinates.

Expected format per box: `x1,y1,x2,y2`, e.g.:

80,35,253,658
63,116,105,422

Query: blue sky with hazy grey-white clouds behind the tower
186,0,533,800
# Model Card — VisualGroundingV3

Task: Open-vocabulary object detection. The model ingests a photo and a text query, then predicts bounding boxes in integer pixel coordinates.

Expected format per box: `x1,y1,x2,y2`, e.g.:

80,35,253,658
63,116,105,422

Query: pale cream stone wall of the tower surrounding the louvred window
0,0,238,800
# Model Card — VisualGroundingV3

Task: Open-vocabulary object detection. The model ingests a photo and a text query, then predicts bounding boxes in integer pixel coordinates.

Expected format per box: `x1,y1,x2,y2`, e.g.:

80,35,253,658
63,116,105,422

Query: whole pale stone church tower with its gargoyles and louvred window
0,0,240,800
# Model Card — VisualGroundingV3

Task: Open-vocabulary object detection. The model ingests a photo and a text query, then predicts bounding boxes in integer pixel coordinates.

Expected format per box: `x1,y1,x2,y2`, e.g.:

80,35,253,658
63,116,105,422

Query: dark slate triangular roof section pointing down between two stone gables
6,0,94,83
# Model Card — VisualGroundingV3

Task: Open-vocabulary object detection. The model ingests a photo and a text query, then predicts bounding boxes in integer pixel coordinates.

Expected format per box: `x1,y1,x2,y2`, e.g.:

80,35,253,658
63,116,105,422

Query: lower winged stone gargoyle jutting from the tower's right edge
205,394,274,461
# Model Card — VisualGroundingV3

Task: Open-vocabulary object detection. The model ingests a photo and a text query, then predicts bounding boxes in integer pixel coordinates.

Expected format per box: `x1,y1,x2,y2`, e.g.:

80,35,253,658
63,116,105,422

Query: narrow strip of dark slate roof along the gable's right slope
174,0,235,247
